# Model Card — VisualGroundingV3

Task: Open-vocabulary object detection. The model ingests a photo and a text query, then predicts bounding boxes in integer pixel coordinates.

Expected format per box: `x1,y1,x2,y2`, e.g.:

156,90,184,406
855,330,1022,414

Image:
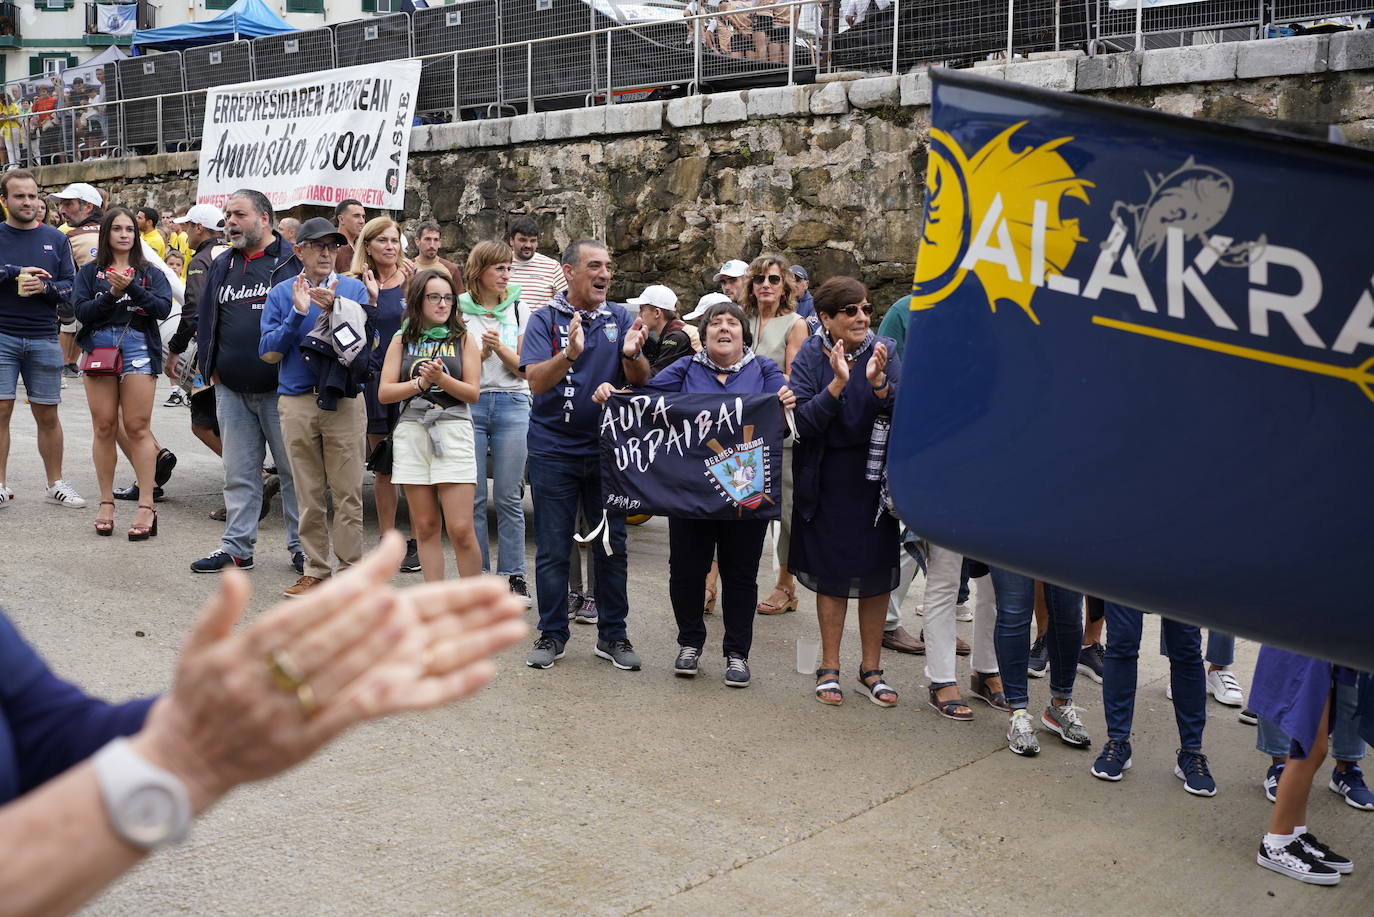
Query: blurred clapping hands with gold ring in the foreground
133,532,526,813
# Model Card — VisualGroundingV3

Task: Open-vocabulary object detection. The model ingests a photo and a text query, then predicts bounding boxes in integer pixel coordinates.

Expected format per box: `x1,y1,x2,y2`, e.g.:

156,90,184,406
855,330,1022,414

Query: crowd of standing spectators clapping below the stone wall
0,170,1374,884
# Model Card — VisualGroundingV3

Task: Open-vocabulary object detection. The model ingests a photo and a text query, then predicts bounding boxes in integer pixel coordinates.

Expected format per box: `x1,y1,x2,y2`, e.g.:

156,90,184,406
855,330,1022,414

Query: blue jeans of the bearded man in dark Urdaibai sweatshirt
214,382,299,557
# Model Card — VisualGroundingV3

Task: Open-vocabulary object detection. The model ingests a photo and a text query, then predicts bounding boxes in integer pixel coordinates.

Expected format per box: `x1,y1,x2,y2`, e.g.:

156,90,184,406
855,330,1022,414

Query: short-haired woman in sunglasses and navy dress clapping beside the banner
790,278,901,707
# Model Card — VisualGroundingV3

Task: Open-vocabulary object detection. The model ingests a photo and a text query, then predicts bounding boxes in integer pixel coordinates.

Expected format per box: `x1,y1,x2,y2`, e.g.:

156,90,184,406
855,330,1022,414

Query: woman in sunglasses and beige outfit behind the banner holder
741,254,807,615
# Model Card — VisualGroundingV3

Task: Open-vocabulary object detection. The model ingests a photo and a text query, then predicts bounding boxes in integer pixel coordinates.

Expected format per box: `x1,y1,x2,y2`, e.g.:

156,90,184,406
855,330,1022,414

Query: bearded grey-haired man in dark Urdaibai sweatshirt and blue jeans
191,188,305,573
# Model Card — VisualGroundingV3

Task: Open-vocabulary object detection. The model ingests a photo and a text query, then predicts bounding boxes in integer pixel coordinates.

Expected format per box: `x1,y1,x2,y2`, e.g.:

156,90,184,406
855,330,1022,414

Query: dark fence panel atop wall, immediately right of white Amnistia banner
411,0,500,120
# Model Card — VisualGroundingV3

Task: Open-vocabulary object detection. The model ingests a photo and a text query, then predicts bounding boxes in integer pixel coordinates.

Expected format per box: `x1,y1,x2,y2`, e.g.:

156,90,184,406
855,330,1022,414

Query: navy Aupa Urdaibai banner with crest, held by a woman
600,392,783,520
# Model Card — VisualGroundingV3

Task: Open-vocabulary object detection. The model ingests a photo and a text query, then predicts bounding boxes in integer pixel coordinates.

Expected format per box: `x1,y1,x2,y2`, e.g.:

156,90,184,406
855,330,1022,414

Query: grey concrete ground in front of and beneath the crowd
0,381,1374,917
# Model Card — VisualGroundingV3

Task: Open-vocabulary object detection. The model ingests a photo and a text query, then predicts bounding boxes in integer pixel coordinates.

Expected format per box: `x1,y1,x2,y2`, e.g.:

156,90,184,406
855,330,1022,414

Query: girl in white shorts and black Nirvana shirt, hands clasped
376,271,482,580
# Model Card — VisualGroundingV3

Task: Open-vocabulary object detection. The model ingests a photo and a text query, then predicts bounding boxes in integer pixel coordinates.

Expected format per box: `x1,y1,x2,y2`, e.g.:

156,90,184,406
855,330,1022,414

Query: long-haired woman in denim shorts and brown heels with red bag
73,208,172,542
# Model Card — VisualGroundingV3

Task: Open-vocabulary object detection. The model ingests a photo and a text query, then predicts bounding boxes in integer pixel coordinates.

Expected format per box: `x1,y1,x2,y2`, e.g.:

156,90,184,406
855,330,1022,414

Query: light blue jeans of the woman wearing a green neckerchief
473,392,529,576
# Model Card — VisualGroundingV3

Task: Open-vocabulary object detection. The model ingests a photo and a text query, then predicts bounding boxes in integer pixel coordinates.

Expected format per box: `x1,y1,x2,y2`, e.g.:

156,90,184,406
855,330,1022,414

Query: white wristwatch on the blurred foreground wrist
91,738,191,850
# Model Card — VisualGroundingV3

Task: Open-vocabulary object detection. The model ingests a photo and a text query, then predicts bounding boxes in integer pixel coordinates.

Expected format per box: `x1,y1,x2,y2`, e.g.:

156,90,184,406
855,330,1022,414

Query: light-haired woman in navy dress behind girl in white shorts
349,216,419,573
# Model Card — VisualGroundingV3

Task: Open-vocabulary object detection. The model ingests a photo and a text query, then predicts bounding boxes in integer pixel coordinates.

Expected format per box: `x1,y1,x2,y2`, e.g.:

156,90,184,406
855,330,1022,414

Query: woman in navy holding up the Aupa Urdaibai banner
595,302,796,687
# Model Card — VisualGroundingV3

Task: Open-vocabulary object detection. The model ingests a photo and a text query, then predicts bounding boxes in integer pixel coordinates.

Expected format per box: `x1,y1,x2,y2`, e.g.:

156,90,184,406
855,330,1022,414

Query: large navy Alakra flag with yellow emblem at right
889,70,1374,670
